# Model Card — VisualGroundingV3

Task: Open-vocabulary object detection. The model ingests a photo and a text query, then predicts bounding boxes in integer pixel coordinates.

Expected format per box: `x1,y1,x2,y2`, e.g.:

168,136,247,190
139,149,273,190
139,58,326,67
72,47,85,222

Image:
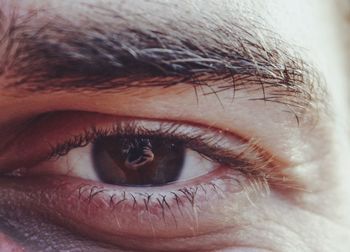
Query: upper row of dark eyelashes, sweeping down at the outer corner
47,120,274,182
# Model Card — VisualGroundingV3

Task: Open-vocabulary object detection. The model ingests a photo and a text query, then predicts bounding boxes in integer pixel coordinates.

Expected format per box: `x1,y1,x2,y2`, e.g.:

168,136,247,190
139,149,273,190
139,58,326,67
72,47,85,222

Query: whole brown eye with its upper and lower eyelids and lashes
2,111,288,250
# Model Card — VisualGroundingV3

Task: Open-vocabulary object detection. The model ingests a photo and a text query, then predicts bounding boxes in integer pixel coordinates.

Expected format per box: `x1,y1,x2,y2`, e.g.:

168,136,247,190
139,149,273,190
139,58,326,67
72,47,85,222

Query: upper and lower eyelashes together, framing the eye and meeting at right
37,119,284,228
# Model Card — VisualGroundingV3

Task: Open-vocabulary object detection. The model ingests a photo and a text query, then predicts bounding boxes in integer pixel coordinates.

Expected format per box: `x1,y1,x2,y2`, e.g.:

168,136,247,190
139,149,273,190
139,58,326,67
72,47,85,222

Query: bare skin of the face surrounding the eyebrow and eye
0,0,350,251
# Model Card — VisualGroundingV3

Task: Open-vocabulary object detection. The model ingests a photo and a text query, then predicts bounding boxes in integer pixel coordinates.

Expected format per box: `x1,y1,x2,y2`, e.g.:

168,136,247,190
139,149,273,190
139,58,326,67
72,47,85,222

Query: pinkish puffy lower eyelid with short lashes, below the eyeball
0,170,247,242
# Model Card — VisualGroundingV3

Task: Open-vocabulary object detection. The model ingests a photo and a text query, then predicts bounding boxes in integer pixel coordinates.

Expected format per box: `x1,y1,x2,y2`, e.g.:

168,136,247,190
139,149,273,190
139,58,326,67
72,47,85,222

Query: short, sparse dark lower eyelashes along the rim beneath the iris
72,176,246,229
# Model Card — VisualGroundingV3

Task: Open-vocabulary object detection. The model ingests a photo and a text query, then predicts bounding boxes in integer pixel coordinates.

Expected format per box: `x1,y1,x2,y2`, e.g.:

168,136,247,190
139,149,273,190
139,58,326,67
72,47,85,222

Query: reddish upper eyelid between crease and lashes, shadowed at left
0,111,268,164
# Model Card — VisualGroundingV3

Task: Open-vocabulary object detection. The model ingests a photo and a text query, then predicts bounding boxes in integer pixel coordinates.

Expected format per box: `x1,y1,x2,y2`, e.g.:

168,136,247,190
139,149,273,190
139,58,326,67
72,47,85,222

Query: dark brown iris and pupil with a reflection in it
93,137,185,186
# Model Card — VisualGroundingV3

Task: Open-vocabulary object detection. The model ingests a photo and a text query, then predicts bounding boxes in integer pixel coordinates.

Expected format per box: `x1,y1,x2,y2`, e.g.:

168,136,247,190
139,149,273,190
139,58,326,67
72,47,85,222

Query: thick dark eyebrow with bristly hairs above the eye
0,1,324,117
